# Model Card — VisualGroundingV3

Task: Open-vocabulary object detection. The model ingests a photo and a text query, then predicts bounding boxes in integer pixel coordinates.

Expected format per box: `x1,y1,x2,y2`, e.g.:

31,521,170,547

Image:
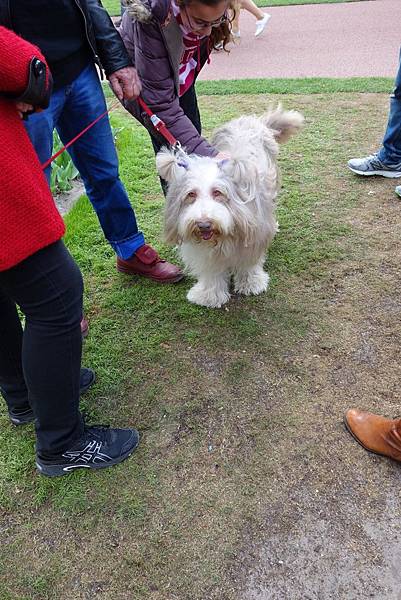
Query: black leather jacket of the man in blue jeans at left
0,0,132,76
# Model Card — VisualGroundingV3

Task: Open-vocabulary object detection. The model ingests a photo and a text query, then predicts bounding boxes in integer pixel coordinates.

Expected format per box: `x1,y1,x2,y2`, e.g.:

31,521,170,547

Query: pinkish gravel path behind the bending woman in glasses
200,0,401,80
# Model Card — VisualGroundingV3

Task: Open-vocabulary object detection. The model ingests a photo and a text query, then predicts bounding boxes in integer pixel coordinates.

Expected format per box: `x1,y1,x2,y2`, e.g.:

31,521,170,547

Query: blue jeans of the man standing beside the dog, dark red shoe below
26,64,145,259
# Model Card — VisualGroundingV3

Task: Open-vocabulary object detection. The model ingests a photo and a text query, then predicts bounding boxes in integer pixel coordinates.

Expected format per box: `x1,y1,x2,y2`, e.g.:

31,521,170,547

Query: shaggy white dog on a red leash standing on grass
156,106,303,307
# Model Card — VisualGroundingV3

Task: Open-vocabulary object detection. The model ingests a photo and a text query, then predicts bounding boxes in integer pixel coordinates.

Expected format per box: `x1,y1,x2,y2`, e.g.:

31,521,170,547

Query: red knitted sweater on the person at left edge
0,27,65,271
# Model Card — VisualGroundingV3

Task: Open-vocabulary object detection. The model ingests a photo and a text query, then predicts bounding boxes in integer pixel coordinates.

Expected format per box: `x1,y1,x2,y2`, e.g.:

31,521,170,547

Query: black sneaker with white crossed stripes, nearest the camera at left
36,425,139,477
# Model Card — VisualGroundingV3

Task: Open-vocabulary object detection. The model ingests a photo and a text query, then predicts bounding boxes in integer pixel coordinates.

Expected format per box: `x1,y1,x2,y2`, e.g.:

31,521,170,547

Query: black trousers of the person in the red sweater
0,241,83,457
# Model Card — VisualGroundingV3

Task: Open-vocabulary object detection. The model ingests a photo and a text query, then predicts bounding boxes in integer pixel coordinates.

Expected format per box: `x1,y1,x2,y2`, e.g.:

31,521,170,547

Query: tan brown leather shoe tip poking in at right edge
344,408,401,462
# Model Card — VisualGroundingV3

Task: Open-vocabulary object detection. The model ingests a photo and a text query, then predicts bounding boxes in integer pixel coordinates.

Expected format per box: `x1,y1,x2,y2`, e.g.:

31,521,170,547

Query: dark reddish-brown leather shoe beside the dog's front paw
117,244,184,283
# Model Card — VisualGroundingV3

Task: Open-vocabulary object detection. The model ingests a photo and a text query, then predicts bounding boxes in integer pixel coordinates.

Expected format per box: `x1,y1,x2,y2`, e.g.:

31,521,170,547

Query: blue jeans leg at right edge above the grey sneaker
378,49,401,166
